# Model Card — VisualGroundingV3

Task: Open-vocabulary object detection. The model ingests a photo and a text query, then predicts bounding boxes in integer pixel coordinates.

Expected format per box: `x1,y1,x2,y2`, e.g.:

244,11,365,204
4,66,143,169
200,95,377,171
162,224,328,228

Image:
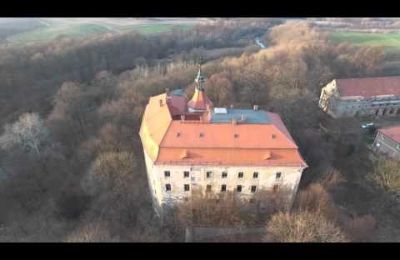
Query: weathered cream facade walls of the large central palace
145,150,304,213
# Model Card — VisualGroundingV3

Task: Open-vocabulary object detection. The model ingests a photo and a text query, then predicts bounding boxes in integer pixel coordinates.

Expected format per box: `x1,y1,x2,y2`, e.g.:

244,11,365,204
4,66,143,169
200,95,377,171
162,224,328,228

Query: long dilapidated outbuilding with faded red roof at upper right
319,77,400,118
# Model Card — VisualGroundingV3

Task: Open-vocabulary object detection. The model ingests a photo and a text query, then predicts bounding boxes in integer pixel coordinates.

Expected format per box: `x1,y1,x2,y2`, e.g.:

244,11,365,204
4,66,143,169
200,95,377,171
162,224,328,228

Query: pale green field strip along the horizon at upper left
3,19,194,44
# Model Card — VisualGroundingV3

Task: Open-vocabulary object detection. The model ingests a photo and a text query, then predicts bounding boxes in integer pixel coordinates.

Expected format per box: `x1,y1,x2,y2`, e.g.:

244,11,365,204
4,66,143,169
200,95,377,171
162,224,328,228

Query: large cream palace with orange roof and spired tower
140,66,307,214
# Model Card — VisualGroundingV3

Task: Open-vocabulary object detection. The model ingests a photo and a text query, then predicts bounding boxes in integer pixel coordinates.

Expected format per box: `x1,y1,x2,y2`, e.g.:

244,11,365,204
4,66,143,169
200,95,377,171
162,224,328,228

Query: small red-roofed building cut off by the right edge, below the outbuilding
373,125,400,160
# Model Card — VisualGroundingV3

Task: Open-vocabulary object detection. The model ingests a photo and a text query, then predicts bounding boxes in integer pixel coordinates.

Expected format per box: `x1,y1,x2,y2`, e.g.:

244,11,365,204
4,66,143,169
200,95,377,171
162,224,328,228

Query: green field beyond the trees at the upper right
330,31,400,52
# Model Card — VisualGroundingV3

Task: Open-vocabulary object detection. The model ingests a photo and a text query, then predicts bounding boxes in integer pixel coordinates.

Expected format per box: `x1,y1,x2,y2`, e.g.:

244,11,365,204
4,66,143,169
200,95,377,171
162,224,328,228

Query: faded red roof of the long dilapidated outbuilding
336,77,400,97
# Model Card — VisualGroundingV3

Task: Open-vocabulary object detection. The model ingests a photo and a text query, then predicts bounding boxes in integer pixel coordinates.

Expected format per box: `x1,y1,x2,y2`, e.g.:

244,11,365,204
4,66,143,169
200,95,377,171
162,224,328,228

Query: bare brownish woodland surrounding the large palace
0,18,400,242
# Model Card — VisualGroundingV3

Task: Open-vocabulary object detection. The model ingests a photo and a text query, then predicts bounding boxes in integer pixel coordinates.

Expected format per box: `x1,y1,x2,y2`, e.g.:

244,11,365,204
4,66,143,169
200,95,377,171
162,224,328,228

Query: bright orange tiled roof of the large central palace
140,91,307,167
